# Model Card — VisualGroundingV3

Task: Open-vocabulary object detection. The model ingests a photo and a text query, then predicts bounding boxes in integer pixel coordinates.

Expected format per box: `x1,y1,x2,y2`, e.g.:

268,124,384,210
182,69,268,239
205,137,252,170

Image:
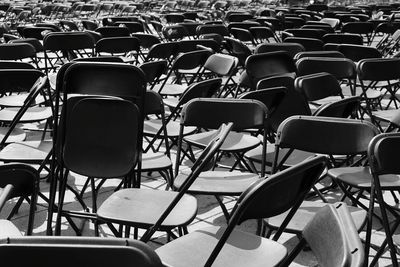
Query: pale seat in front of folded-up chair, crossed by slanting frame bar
97,188,197,229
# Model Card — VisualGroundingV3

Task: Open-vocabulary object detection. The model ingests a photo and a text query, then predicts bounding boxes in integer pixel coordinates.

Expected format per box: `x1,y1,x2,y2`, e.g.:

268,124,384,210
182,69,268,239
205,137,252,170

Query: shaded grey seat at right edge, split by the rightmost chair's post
328,167,400,190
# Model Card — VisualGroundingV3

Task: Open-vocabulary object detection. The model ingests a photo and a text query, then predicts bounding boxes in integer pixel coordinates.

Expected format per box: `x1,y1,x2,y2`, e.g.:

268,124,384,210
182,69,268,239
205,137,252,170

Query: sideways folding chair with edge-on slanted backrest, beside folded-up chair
97,123,232,242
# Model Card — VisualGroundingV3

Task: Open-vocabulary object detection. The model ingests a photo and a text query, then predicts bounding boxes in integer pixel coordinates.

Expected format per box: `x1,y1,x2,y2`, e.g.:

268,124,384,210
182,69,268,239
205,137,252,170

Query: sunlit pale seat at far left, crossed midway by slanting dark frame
0,107,53,122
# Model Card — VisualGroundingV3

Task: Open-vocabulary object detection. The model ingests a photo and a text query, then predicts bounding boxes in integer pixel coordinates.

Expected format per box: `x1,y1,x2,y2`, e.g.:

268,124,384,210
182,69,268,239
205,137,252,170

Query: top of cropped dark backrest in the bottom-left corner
0,236,163,267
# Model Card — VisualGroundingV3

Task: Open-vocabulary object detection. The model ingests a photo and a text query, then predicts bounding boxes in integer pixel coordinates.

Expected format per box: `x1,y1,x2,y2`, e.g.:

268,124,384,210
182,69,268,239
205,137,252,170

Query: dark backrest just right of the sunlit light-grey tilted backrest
246,51,296,88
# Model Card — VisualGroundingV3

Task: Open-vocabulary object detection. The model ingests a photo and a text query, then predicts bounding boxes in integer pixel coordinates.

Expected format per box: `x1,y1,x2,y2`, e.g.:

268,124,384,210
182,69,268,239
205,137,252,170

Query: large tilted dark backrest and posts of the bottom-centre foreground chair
205,156,326,266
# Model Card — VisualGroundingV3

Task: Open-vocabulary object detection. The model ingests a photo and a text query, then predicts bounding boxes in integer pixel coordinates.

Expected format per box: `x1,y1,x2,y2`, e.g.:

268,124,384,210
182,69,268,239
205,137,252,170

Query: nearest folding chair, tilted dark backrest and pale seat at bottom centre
156,157,325,267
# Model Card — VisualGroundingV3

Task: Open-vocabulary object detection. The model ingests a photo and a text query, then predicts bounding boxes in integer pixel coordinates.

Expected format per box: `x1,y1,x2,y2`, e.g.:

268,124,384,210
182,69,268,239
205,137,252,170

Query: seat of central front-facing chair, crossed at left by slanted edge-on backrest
174,170,260,196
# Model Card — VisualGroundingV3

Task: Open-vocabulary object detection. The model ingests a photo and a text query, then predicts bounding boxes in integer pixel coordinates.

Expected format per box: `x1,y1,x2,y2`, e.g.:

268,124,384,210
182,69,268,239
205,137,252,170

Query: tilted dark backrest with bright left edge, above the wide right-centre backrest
294,72,342,101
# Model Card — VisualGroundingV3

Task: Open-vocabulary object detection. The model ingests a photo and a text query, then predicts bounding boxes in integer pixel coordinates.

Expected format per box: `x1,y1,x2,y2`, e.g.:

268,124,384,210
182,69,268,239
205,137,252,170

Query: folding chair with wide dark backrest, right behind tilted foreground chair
264,116,370,244
